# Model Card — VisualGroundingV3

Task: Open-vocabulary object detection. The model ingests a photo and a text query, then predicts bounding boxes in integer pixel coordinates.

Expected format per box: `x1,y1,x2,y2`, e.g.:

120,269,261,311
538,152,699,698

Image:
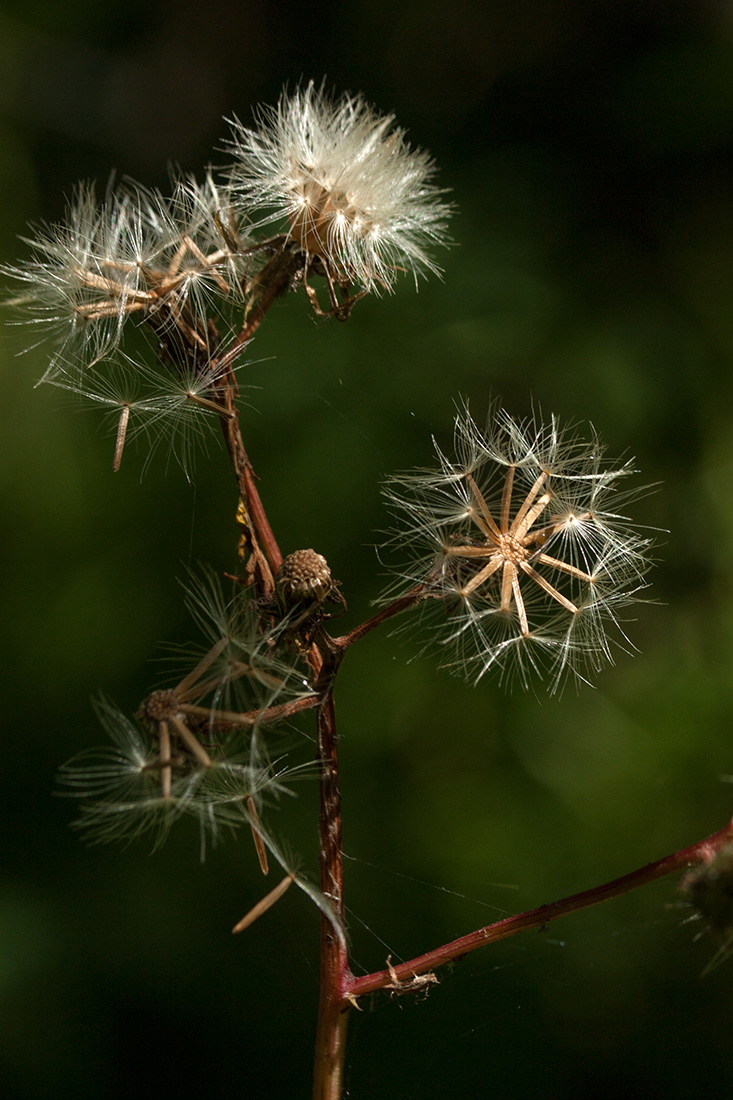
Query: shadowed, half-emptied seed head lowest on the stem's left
59,574,315,846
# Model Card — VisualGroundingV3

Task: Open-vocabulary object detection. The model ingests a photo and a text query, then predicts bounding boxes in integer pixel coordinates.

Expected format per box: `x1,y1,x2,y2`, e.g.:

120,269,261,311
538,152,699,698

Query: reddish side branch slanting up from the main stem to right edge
346,822,733,997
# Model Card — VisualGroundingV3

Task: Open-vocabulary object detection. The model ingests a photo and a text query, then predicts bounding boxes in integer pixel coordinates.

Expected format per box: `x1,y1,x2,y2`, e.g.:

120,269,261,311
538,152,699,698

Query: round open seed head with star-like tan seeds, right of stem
386,408,650,691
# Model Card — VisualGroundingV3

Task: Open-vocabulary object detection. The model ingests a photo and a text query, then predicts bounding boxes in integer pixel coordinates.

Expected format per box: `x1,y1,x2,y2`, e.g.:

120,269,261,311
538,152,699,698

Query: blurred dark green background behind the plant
0,0,733,1100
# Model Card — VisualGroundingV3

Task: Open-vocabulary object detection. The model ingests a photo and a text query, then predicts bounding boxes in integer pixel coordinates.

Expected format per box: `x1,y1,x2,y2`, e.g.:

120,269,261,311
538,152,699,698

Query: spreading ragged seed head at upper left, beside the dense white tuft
4,173,247,381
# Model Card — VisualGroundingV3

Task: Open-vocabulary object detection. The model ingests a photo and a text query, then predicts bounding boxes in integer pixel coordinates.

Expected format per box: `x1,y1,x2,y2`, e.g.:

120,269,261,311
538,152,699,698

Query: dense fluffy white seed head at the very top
225,81,450,290
